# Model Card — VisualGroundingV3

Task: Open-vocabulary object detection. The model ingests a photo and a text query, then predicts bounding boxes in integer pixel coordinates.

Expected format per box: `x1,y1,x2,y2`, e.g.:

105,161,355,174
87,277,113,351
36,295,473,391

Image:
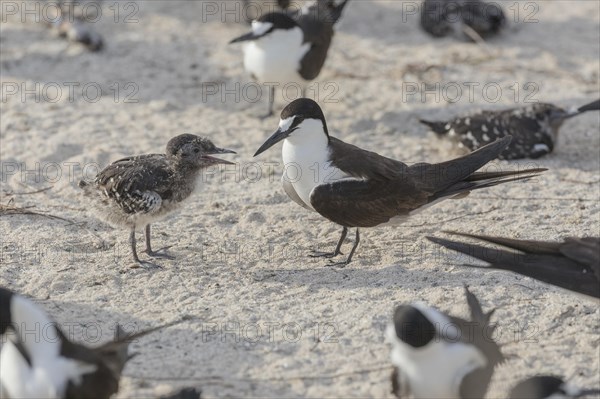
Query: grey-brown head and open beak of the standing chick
167,133,235,168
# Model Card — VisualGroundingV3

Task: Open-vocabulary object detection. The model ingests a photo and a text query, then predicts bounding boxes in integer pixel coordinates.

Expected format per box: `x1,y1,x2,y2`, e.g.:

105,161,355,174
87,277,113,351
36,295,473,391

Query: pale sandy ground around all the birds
0,0,600,398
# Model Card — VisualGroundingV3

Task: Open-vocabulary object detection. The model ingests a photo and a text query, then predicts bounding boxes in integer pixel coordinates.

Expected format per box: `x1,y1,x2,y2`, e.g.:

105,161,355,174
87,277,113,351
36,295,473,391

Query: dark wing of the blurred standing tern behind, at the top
296,3,333,80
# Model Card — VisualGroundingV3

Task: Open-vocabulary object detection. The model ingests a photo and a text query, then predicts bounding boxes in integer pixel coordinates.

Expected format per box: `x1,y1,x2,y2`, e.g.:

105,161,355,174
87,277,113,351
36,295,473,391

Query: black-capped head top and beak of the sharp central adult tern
254,98,329,156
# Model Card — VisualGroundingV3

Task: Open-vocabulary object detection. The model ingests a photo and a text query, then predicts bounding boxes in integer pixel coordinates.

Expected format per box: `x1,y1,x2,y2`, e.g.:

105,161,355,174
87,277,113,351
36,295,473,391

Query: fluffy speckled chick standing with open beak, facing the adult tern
79,134,234,268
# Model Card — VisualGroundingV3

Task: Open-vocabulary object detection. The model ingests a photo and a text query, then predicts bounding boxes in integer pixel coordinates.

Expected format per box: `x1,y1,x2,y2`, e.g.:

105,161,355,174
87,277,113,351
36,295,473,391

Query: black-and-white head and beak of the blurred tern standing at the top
229,12,304,46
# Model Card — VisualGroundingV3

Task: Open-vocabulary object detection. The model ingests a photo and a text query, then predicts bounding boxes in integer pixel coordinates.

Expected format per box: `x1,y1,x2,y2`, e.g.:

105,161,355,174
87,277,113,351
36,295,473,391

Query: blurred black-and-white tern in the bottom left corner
0,287,179,399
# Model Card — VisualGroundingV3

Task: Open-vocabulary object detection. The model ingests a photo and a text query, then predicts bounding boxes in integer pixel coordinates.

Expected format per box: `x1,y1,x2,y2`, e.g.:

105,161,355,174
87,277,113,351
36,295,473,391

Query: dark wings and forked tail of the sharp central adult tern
310,137,541,227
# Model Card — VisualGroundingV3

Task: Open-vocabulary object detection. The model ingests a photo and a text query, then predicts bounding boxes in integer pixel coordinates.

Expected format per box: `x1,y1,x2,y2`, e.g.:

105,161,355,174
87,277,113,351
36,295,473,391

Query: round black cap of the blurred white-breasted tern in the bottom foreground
394,305,436,348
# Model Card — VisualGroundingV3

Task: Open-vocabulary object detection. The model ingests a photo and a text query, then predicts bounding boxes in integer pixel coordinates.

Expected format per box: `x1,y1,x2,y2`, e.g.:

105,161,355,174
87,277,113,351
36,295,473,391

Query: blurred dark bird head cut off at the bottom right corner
508,375,600,399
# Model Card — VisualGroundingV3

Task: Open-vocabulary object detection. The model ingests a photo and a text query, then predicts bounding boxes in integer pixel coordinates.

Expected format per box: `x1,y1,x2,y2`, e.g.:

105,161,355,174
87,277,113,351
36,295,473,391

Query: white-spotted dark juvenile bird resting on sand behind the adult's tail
421,101,599,159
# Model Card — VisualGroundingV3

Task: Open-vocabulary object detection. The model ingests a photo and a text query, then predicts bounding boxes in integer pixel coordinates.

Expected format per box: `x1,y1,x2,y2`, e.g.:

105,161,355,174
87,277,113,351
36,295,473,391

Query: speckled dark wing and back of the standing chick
95,154,174,213
